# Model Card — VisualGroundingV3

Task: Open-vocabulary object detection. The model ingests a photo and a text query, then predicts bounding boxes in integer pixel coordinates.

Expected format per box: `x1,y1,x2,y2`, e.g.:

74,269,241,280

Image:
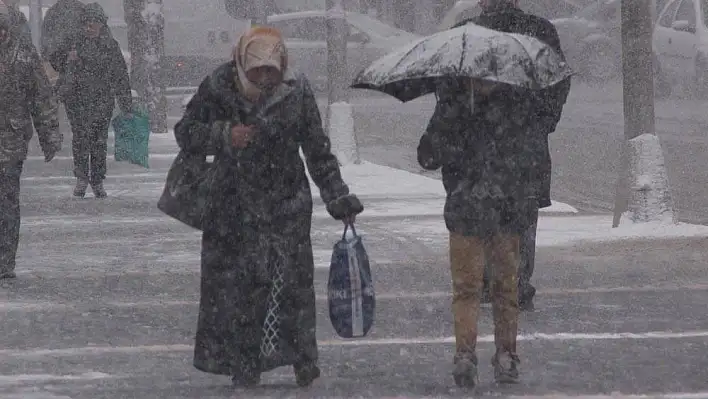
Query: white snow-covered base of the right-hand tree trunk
628,134,676,224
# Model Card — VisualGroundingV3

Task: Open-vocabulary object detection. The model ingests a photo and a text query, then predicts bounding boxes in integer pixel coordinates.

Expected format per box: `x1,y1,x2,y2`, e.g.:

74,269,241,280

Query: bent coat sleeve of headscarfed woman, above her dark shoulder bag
175,77,225,154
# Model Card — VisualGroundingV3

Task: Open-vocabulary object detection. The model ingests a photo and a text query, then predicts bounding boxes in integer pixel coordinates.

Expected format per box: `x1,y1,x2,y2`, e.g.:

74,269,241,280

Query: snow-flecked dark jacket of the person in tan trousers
418,82,540,237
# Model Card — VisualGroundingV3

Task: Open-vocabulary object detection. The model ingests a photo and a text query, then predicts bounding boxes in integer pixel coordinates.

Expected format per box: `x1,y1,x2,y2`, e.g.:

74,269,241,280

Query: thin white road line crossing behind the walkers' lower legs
0,331,708,359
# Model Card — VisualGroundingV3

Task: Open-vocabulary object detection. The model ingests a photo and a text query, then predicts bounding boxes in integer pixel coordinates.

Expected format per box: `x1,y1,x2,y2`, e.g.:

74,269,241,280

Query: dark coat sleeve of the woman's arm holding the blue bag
300,78,349,204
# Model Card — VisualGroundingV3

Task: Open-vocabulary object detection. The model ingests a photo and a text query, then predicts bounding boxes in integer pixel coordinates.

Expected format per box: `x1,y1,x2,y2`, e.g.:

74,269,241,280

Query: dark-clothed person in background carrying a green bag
51,3,133,198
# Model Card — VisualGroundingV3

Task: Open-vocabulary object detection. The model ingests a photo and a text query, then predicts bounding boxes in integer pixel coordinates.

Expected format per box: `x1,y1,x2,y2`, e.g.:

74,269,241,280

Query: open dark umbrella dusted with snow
351,23,572,102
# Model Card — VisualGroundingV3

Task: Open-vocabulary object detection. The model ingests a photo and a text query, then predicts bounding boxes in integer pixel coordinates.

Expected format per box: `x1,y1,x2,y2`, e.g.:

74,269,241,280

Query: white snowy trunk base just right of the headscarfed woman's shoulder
329,102,361,165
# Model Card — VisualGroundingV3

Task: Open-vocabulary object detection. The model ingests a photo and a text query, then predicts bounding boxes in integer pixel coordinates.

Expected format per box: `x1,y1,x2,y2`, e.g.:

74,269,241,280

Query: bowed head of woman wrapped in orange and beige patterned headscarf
233,27,288,101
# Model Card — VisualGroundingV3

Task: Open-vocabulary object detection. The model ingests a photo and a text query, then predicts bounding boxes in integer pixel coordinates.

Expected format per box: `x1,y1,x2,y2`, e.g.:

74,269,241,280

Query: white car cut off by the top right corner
653,0,708,97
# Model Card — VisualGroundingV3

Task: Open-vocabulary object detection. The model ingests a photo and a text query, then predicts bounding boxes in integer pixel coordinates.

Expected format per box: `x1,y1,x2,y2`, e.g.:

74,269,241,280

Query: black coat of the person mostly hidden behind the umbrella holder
457,3,570,208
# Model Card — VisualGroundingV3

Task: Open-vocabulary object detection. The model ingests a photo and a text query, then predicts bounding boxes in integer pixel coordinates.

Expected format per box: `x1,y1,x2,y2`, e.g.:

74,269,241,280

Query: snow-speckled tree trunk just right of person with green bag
123,0,167,133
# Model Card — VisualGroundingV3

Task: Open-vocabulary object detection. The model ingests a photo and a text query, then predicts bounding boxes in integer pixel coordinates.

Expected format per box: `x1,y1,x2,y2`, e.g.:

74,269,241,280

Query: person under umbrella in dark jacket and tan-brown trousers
418,76,535,387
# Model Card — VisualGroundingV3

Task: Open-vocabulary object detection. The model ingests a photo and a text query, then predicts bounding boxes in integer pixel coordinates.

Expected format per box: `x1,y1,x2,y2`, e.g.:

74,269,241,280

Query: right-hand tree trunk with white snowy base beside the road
612,0,668,227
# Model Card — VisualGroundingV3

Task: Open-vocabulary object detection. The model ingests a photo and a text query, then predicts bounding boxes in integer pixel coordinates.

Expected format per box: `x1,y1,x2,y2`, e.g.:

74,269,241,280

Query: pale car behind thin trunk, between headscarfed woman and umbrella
267,10,419,89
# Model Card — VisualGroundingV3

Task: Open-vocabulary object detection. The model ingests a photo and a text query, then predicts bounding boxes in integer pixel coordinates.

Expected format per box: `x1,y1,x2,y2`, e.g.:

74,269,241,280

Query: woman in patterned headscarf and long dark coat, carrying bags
175,27,363,386
